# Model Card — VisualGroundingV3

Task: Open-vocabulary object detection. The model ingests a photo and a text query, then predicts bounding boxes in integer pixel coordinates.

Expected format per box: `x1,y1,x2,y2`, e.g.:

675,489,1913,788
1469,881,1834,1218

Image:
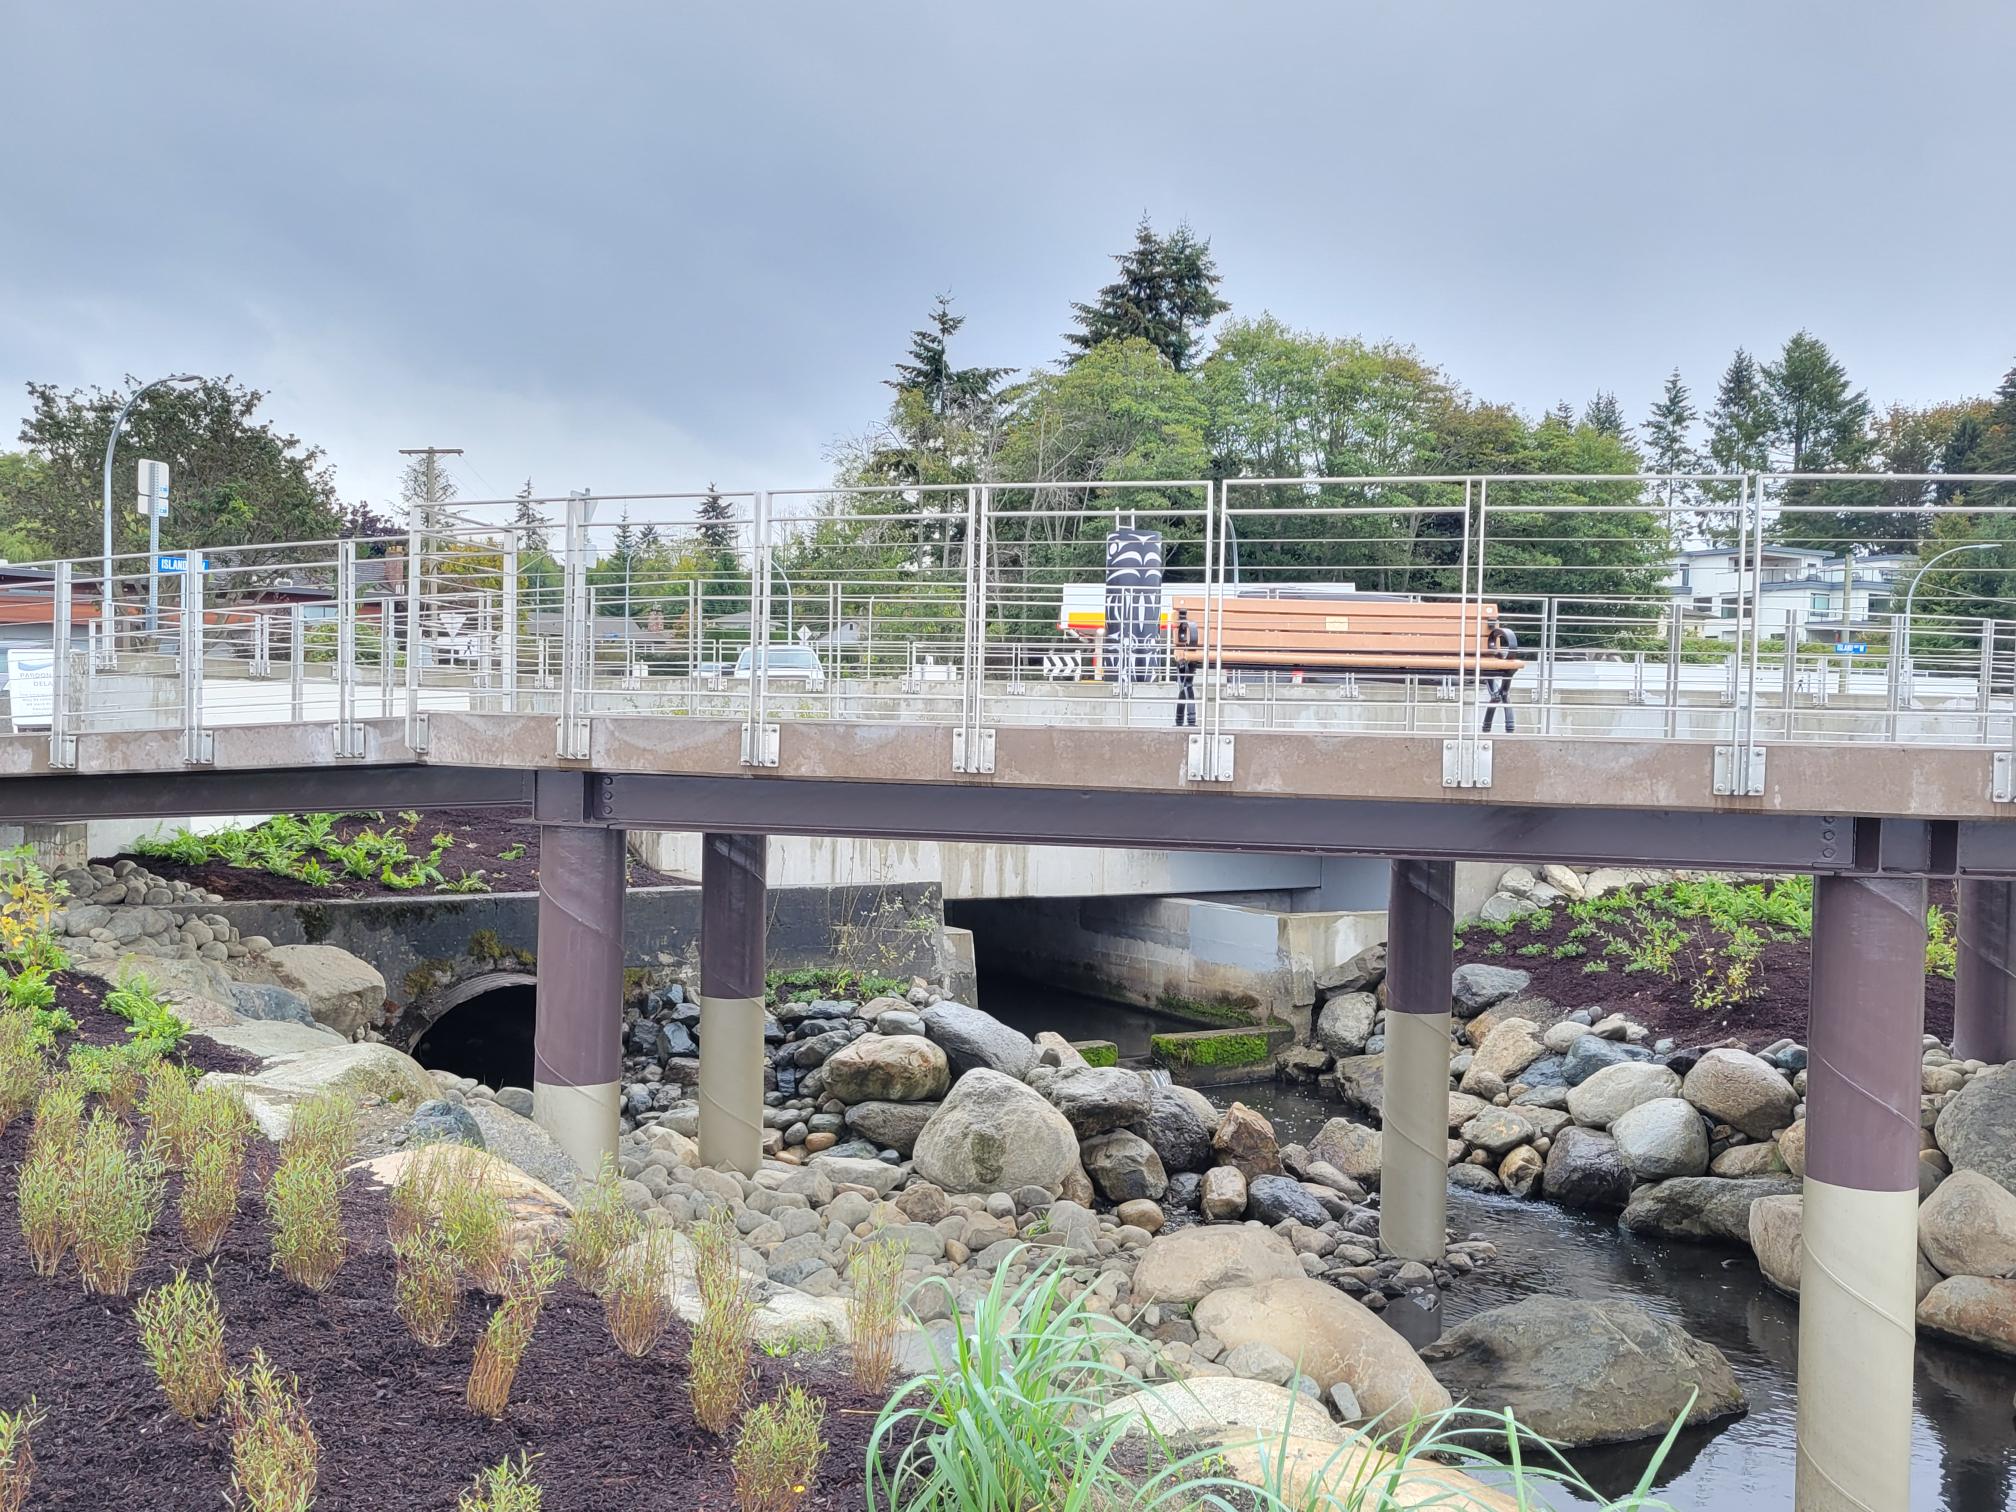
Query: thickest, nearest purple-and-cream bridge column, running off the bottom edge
1796,877,1925,1512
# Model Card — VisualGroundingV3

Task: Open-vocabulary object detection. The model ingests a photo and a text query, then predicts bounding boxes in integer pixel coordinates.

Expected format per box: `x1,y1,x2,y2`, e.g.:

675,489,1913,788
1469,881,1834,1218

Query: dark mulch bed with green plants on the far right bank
1456,883,1954,1050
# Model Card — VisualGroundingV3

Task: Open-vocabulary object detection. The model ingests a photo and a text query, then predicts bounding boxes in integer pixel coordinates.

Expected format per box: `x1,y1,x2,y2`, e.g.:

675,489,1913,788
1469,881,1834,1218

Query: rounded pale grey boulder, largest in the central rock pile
911,1072,1079,1195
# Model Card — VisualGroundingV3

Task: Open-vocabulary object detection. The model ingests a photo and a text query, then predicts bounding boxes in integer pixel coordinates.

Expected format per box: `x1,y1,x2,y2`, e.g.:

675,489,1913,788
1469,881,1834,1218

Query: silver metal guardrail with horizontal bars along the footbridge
0,474,2016,794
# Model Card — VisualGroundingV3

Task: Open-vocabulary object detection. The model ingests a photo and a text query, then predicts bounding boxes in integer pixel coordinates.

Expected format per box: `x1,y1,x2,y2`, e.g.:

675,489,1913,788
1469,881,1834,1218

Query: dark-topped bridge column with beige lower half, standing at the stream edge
1379,861,1456,1264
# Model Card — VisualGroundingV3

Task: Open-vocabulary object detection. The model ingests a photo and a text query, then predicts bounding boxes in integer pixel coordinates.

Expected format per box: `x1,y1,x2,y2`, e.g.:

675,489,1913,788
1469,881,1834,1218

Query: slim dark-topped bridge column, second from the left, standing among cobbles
700,835,768,1175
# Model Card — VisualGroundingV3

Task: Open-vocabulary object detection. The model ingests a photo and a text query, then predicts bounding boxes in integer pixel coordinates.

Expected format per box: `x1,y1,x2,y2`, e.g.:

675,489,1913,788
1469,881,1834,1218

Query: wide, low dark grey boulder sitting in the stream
1421,1296,1748,1447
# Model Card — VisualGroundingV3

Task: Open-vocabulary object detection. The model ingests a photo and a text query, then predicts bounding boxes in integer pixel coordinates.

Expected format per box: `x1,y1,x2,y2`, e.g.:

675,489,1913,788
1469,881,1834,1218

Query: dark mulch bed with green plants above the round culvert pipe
105,808,679,903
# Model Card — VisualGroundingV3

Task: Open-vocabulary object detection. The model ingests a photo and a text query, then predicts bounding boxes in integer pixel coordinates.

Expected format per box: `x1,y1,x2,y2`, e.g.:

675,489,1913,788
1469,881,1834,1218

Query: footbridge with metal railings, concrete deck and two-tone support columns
0,474,2016,1508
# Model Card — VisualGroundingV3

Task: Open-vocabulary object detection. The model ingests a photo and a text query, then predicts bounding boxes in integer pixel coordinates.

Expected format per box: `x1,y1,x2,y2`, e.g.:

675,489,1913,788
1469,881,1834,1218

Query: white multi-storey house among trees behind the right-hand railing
1667,546,1917,641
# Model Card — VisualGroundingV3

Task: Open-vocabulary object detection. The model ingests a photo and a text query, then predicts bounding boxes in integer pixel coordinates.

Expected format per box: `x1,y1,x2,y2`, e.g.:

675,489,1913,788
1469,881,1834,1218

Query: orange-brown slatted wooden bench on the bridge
1171,595,1520,677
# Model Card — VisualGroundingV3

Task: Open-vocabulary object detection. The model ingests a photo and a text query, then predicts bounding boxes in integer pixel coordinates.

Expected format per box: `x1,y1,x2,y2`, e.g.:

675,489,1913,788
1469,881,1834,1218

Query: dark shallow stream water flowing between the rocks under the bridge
982,980,2016,1512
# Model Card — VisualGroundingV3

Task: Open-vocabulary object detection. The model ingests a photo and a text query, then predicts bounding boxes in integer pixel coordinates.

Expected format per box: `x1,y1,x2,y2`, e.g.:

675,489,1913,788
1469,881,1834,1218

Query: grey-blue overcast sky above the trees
0,0,2016,516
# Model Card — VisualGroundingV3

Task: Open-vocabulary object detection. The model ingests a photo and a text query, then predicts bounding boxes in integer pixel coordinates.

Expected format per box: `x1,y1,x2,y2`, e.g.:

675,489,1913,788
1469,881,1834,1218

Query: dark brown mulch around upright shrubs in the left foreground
0,1119,879,1512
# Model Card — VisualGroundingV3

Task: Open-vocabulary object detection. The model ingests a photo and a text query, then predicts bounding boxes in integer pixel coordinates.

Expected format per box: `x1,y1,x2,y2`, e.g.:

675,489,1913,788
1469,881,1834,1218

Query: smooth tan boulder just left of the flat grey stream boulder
1191,1276,1450,1421
